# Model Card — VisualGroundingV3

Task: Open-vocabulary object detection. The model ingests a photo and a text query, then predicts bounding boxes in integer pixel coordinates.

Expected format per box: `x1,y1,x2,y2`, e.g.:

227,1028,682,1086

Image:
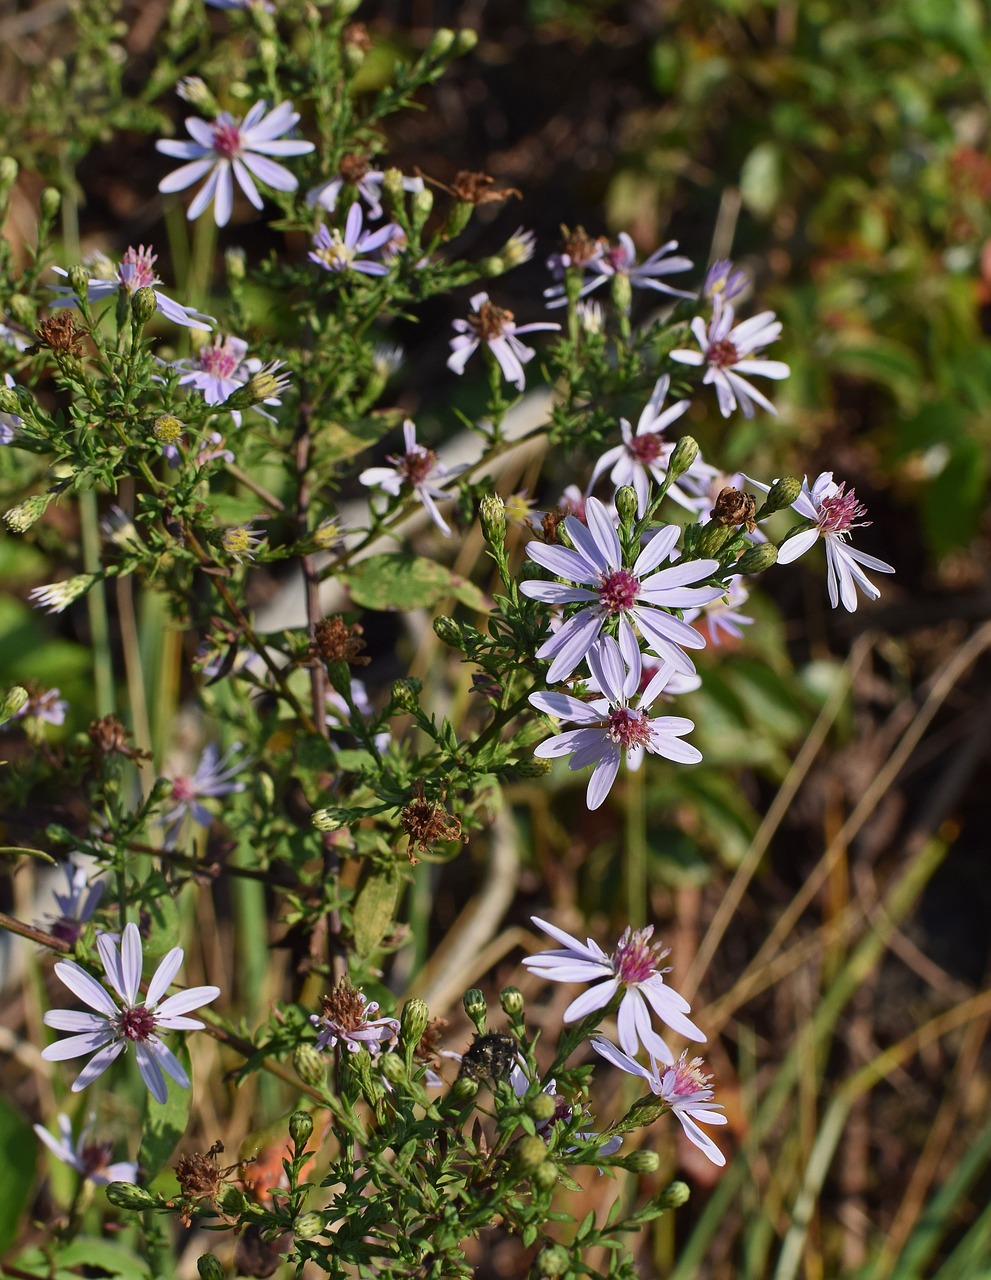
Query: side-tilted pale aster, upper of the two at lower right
524,915,705,1062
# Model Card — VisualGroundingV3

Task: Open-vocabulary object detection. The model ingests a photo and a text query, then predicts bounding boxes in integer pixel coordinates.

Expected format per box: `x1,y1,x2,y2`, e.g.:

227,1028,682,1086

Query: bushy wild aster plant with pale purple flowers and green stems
0,0,906,1280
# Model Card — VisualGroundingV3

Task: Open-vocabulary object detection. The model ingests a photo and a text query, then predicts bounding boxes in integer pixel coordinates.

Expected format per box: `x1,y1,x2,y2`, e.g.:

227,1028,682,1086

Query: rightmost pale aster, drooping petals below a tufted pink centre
750,471,895,613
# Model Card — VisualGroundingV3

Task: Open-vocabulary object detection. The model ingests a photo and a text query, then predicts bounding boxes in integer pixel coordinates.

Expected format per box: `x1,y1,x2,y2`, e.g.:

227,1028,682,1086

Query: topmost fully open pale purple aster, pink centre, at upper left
155,102,314,227
